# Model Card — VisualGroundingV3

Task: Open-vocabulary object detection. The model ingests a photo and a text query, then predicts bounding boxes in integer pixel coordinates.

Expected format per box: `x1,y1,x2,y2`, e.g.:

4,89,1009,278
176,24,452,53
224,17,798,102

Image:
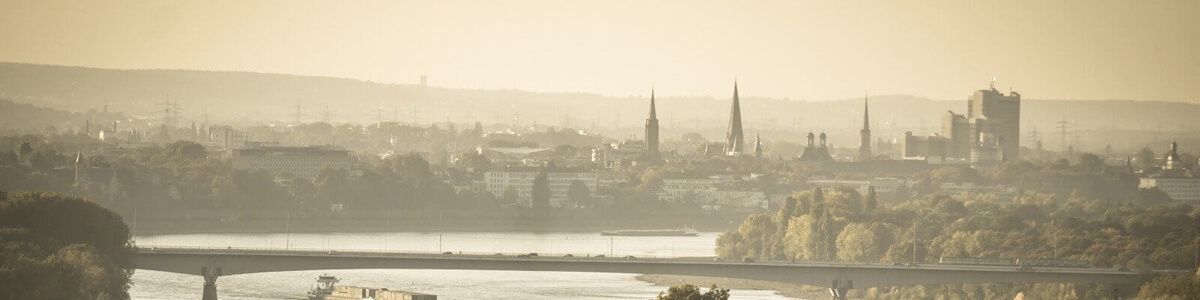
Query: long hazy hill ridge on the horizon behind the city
0,64,1200,152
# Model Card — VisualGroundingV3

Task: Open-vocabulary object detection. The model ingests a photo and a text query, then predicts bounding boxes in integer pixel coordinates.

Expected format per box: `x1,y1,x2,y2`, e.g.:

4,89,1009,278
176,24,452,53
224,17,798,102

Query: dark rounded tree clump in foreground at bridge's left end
0,192,133,299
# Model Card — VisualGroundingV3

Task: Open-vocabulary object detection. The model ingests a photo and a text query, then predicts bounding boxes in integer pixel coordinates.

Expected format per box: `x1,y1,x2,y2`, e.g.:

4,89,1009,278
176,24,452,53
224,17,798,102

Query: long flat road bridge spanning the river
133,247,1171,300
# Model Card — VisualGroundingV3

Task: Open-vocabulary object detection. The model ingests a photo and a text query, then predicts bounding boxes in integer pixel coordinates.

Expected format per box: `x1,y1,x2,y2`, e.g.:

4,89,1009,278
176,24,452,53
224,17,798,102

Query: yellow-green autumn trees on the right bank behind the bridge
718,190,1200,299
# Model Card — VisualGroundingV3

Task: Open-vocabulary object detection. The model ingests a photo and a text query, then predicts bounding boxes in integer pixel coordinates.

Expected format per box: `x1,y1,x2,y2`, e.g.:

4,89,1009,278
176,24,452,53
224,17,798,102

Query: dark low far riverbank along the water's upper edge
126,207,746,235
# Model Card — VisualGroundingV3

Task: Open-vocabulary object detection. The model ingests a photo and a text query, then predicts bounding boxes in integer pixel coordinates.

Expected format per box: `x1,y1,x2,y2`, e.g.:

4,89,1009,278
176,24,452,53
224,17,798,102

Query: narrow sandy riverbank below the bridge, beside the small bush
636,274,829,300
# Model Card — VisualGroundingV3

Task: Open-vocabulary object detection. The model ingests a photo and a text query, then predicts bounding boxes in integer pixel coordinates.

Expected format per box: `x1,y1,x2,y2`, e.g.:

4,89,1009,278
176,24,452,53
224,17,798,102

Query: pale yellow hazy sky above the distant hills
0,0,1200,102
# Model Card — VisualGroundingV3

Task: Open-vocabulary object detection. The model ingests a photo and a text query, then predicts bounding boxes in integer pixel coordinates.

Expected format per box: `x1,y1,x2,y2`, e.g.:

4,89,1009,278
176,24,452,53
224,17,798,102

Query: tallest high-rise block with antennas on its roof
967,82,1021,161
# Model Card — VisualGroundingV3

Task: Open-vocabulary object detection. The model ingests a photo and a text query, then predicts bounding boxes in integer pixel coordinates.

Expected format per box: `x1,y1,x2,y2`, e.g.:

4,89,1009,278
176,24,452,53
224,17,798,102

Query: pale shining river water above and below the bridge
130,233,787,300
